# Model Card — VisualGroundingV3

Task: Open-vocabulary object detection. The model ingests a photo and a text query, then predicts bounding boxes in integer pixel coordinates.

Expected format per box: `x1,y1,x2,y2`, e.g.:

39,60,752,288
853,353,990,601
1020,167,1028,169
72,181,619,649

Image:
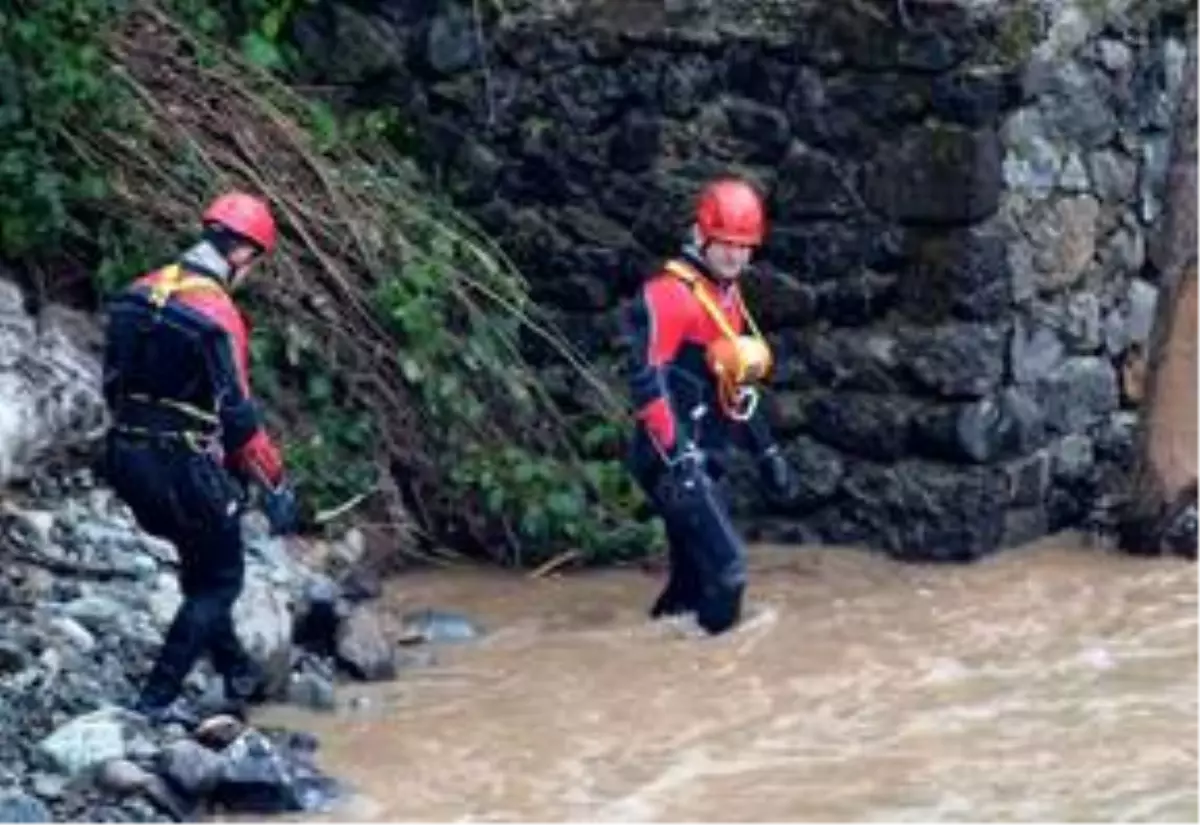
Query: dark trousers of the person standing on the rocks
106,433,257,707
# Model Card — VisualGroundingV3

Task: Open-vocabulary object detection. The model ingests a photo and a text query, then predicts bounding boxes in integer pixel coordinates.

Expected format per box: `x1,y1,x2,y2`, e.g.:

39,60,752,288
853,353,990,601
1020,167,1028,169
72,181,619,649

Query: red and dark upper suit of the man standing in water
626,249,773,454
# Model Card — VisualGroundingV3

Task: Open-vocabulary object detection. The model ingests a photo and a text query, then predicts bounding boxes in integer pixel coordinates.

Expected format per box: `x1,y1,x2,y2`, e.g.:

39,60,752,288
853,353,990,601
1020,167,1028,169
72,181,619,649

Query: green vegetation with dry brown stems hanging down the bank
0,0,658,565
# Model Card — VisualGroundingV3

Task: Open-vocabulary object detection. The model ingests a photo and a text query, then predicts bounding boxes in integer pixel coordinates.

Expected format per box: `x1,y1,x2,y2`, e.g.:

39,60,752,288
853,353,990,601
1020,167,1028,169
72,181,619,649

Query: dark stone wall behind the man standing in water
288,0,1184,559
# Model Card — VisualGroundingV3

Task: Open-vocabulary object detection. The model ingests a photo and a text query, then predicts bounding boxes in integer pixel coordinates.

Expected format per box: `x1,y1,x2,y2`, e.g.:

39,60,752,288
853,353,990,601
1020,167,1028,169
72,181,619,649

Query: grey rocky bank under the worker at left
0,281,478,825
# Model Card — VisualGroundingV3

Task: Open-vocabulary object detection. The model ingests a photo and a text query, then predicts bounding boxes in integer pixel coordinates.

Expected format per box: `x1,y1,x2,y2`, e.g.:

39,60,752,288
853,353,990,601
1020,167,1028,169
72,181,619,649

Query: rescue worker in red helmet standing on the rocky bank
103,192,298,716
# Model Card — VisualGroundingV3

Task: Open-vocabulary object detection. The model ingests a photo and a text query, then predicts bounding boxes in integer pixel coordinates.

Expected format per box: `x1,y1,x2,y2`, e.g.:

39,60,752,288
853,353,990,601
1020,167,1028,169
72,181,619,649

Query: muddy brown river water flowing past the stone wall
225,536,1200,825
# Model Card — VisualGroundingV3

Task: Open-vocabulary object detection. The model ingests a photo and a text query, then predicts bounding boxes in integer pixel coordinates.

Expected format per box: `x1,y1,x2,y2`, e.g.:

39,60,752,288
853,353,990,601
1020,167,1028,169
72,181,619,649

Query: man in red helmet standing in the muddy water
629,179,797,634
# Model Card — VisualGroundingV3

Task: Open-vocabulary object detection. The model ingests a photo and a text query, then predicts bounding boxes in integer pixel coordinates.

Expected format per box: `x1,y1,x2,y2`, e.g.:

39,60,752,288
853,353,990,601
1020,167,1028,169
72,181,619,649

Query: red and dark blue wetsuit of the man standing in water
628,251,790,633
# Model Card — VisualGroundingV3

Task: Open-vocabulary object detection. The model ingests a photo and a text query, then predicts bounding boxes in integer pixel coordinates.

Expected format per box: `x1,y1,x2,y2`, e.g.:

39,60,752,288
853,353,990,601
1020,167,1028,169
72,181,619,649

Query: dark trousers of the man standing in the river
629,428,745,634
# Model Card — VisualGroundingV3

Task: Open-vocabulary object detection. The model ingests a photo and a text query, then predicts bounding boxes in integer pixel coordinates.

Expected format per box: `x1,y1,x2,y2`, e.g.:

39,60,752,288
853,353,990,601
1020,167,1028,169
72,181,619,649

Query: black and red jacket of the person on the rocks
104,257,283,489
